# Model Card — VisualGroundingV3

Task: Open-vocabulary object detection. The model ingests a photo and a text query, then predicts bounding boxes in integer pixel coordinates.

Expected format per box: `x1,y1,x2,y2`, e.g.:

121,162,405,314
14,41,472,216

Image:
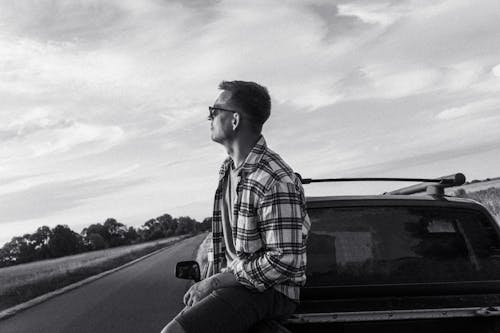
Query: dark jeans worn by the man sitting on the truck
174,286,297,333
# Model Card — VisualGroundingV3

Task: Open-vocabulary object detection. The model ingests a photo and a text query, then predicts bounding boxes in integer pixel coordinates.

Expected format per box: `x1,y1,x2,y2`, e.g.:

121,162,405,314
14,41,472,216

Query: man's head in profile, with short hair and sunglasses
209,81,271,143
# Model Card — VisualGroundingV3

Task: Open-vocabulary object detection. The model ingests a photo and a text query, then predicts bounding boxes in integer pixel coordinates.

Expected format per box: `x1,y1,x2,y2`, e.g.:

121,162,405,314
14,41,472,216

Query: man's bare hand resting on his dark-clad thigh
184,272,240,306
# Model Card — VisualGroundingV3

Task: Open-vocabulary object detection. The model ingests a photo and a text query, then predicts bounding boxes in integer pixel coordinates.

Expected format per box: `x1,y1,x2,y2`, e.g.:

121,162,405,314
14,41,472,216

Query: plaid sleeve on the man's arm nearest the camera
230,182,306,291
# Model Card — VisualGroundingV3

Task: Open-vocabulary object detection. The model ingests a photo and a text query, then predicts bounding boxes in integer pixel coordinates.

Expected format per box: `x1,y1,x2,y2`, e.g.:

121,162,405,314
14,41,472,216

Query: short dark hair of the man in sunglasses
219,81,271,132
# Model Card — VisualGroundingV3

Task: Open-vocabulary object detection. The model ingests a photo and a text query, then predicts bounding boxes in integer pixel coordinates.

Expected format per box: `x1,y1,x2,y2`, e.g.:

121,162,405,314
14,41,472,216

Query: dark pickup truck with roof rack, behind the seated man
176,173,500,333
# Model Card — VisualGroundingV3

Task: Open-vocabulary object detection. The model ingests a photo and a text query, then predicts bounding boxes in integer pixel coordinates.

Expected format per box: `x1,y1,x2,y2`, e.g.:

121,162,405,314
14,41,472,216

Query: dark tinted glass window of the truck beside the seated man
307,207,500,286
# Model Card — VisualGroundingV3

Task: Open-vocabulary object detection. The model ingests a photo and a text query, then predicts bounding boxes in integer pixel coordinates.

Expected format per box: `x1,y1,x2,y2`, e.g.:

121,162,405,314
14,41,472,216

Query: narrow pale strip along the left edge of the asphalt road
0,235,193,320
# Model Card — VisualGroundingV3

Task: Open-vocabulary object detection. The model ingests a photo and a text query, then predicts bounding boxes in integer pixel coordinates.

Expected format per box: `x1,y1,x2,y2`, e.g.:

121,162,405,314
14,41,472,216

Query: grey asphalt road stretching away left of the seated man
0,234,205,333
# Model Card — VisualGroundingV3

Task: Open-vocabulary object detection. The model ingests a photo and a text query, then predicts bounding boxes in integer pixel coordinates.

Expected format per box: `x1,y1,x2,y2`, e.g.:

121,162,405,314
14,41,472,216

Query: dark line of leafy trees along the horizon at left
0,214,212,267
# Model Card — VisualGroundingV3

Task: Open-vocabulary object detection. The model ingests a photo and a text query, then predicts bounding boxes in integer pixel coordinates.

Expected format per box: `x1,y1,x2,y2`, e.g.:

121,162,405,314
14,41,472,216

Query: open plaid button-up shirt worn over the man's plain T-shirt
208,137,311,302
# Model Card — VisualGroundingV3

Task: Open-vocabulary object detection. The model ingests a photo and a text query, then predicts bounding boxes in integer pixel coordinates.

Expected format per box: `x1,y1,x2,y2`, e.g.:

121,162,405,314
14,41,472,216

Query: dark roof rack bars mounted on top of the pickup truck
296,173,465,196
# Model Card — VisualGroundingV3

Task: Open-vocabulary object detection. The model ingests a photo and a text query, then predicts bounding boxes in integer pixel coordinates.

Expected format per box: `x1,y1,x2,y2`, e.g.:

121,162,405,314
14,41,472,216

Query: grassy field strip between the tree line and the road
0,236,185,311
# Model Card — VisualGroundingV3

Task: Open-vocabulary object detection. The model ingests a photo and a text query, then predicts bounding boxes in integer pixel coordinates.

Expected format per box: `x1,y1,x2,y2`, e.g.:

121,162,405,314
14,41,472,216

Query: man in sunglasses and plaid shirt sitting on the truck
162,81,310,333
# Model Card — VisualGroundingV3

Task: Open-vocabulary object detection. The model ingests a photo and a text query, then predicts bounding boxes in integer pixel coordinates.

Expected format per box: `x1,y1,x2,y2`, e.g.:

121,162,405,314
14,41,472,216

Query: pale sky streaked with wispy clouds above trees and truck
0,0,500,244
